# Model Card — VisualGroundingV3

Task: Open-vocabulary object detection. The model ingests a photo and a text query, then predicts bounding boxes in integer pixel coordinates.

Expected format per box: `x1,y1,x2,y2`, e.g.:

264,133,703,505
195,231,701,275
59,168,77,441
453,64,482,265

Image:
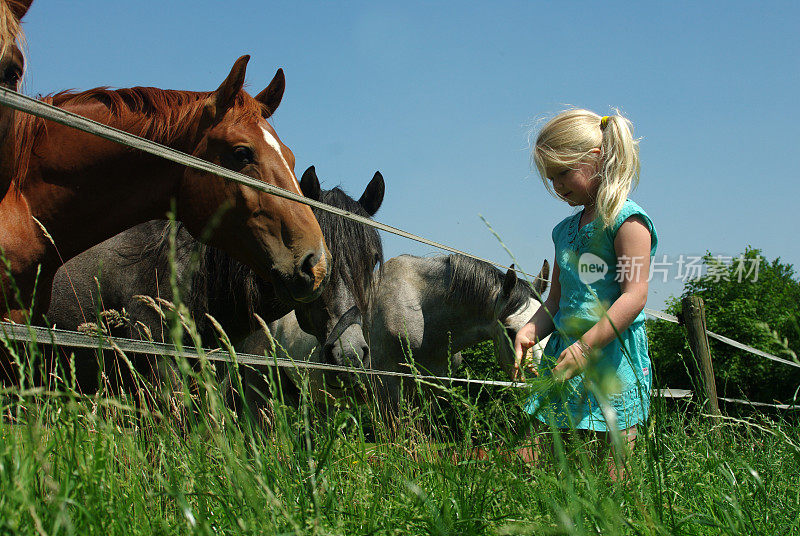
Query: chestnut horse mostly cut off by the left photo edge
0,0,33,198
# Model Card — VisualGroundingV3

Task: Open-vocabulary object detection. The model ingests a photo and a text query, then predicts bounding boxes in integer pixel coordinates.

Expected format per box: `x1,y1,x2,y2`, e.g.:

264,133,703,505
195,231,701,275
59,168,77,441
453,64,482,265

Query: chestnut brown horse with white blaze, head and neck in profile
0,56,330,321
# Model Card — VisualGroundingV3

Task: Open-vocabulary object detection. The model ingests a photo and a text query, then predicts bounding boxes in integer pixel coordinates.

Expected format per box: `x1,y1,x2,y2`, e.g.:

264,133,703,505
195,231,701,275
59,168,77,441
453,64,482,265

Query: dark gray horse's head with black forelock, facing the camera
295,166,385,384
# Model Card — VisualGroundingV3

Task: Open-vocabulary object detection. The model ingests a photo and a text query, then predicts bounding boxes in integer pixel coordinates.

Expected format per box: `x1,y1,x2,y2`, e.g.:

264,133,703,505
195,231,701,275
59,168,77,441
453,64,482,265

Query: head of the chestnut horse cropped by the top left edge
0,0,33,155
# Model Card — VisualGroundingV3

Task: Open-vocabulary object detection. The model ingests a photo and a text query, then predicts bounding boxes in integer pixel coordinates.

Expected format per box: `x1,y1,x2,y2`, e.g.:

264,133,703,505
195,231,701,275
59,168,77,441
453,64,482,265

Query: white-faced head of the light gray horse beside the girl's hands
492,261,550,372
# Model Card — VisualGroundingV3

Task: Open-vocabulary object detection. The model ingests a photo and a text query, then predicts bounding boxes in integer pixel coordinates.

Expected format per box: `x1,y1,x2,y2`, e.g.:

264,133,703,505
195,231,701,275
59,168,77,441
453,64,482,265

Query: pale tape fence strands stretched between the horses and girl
0,87,800,409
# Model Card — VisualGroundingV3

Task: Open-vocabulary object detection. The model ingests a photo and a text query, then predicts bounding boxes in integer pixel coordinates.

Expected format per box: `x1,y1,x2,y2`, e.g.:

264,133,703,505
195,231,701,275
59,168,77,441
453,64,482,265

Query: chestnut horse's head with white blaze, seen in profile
178,56,331,302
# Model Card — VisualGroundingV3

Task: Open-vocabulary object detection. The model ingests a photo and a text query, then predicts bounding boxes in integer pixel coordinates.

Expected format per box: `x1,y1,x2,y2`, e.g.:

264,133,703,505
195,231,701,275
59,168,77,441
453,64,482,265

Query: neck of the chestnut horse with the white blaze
20,99,196,259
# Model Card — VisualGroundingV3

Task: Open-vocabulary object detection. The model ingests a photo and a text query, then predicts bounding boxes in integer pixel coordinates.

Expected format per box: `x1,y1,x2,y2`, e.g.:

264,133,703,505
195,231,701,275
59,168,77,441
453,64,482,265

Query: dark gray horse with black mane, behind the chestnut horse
47,166,385,398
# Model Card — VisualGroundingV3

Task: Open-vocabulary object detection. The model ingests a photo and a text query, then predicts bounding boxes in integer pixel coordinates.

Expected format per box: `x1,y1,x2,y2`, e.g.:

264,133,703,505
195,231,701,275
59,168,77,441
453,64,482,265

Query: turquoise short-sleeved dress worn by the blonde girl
525,199,658,431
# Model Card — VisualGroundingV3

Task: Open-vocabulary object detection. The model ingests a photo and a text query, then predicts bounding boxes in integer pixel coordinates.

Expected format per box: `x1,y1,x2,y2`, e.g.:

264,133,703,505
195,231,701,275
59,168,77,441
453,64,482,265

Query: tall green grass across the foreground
0,338,800,535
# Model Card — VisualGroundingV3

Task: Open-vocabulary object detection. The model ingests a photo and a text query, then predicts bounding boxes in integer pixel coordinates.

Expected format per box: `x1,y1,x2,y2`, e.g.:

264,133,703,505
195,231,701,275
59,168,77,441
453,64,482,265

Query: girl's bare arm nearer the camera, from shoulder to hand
553,216,650,380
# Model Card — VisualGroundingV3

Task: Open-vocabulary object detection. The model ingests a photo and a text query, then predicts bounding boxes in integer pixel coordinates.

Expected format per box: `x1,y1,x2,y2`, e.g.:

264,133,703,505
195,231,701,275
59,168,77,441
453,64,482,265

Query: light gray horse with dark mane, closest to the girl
243,255,549,414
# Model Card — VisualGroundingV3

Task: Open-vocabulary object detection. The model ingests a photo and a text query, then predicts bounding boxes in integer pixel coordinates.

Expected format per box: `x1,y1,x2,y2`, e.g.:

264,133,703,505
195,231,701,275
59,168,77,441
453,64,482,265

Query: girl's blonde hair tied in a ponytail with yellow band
531,108,639,228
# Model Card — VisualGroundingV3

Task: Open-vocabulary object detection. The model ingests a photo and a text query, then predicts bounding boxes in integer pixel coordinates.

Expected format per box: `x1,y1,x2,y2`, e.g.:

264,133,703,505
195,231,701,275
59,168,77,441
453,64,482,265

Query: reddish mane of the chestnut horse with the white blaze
10,85,264,189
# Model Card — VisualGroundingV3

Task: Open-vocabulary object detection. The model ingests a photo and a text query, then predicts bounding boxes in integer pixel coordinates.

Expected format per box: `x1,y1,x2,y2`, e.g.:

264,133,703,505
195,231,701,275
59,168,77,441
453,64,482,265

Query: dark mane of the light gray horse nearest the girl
445,255,536,319
